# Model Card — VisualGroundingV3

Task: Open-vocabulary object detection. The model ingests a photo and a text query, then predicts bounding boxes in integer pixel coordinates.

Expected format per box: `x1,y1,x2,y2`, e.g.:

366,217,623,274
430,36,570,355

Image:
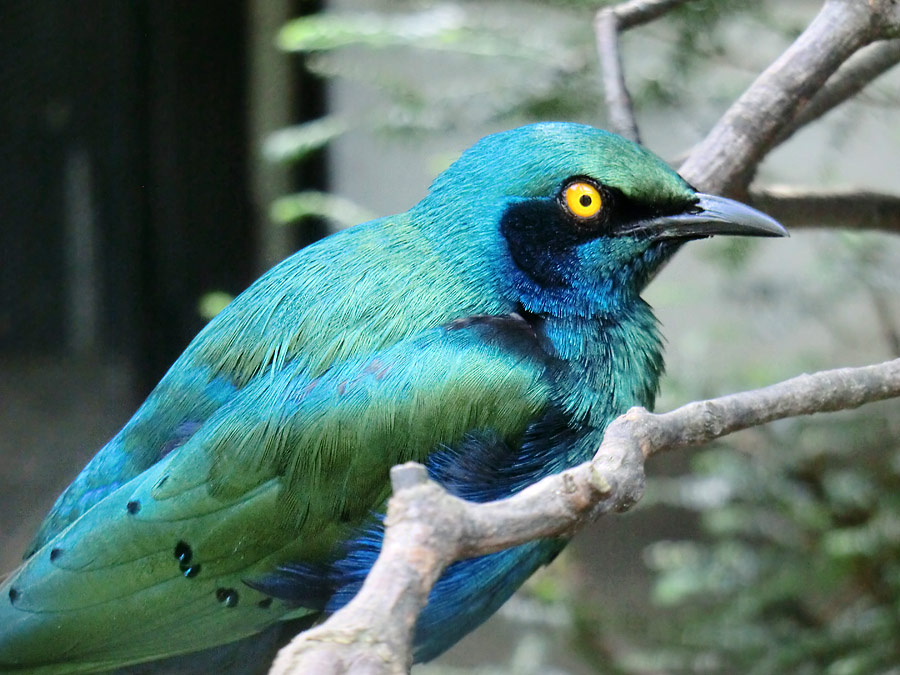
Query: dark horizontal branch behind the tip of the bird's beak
748,186,900,234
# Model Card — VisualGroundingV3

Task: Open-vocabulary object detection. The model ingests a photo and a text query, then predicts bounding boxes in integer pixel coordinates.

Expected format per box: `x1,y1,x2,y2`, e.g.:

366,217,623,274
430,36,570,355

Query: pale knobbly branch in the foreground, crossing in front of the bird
269,359,900,675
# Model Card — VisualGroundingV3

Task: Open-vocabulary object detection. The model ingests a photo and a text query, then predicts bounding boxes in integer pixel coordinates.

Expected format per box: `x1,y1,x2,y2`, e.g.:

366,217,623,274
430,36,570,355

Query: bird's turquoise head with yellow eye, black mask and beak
418,123,787,311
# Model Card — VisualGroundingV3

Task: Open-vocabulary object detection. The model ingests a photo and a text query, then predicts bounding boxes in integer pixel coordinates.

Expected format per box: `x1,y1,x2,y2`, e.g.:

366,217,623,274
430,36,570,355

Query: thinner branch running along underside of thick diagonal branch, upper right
775,39,900,145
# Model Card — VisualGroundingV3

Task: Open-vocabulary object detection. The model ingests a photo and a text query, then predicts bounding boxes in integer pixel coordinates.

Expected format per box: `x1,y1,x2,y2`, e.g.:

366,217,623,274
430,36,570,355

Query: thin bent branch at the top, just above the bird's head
594,0,686,143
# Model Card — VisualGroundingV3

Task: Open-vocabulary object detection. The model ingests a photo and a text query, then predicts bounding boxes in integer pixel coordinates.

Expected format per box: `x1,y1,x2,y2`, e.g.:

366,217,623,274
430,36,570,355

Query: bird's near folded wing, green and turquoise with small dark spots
0,318,550,672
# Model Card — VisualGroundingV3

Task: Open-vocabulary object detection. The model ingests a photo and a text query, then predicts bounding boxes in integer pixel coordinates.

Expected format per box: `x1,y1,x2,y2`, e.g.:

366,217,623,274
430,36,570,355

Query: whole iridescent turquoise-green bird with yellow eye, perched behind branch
0,122,787,674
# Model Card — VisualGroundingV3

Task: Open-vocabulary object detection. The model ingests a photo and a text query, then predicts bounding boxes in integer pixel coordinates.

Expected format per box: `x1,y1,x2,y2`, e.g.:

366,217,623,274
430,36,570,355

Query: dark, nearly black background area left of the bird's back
0,0,323,574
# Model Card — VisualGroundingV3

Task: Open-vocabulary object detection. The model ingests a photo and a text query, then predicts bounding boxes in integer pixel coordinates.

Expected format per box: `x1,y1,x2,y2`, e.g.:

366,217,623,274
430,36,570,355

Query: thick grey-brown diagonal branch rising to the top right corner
679,0,900,194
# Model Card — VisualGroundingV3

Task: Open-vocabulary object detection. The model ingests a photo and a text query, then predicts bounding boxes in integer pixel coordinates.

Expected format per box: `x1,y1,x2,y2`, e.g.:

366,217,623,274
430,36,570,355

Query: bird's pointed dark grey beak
618,192,789,240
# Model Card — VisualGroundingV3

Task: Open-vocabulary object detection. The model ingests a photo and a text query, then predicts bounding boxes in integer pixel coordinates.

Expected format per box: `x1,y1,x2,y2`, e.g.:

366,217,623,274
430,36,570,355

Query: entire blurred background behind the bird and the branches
0,0,900,675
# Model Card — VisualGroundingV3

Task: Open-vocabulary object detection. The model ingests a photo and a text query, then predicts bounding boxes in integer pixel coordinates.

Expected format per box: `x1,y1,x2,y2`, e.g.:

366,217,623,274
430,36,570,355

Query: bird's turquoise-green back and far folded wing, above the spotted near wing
26,214,492,557
